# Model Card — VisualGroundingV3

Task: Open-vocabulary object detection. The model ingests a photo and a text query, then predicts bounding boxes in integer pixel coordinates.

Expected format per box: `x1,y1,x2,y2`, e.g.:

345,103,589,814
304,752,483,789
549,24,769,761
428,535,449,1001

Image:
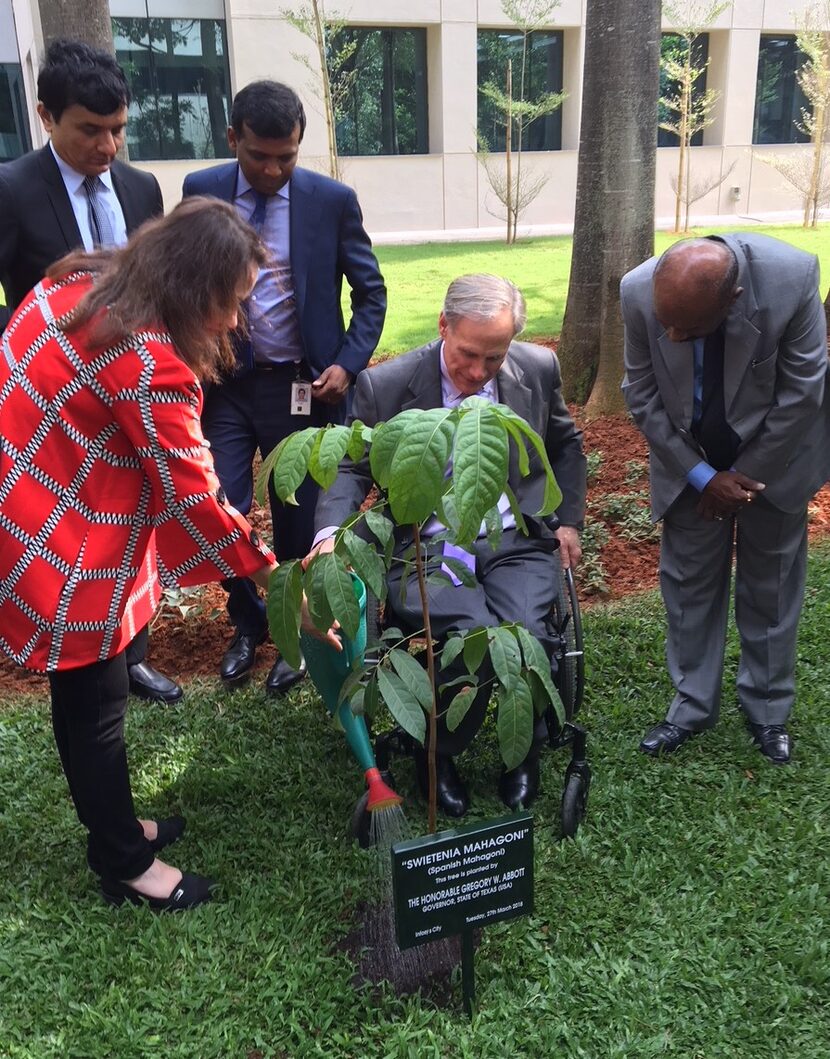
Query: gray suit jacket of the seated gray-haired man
314,339,585,533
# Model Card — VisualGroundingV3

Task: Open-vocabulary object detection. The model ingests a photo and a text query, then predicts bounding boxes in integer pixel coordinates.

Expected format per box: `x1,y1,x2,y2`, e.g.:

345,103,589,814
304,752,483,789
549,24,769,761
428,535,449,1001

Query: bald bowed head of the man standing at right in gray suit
653,239,741,342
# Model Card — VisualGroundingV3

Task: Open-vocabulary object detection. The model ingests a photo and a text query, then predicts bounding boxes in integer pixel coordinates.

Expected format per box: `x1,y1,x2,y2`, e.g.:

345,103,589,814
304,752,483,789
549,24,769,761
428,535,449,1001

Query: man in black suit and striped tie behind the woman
0,40,182,703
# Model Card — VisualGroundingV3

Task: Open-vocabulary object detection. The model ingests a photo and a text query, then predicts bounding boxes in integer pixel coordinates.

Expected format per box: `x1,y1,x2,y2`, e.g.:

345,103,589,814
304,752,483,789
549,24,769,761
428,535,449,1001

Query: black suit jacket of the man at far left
0,144,164,324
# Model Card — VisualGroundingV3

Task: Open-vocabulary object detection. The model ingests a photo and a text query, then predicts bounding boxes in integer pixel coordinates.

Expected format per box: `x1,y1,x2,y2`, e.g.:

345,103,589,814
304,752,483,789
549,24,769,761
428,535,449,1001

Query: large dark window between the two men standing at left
112,18,231,161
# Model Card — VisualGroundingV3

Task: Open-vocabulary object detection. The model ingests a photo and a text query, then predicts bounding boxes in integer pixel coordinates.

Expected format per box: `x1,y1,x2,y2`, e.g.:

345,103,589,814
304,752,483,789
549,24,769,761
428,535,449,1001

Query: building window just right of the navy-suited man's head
331,26,429,155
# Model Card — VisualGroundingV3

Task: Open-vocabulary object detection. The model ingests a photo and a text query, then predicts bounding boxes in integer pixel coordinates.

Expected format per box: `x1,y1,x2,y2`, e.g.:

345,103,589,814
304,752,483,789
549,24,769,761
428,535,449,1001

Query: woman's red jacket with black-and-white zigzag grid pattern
0,274,274,671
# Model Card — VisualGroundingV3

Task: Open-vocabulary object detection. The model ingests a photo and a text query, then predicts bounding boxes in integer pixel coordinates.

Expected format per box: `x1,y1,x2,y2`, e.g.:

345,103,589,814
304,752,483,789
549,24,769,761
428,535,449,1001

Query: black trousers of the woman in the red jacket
49,651,155,879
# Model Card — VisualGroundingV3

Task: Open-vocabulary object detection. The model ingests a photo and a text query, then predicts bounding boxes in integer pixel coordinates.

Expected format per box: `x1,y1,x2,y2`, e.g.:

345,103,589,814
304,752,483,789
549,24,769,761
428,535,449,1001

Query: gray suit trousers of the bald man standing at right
660,486,807,732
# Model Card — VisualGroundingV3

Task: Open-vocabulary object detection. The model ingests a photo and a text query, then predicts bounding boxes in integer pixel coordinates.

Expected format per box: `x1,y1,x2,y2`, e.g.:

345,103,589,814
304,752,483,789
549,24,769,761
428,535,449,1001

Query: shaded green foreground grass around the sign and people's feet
0,546,830,1059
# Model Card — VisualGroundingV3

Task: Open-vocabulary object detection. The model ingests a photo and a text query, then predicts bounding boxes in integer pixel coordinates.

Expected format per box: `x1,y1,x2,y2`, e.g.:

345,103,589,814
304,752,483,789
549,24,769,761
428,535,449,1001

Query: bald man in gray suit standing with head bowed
620,234,829,764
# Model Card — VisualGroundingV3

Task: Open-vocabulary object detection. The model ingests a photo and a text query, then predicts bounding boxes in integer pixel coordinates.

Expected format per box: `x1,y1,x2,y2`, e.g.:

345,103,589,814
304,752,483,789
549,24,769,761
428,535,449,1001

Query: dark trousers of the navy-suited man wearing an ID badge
202,363,328,636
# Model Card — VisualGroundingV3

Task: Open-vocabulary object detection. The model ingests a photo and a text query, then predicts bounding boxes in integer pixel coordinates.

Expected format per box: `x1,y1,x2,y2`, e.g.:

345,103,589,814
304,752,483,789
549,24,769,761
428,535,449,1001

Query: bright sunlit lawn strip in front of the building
374,225,830,355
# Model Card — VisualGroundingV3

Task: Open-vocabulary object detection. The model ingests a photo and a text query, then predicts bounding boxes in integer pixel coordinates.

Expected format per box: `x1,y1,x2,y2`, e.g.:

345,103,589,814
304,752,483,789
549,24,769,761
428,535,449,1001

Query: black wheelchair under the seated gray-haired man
350,553,591,847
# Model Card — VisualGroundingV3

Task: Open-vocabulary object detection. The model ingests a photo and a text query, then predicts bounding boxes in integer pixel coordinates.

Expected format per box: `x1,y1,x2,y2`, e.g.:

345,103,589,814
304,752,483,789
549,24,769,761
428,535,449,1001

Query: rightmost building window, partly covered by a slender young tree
753,35,811,143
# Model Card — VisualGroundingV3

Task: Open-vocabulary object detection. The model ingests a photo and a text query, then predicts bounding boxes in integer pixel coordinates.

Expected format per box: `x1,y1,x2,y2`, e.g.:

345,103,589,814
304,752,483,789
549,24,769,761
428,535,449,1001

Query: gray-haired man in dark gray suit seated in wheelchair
307,275,585,816
